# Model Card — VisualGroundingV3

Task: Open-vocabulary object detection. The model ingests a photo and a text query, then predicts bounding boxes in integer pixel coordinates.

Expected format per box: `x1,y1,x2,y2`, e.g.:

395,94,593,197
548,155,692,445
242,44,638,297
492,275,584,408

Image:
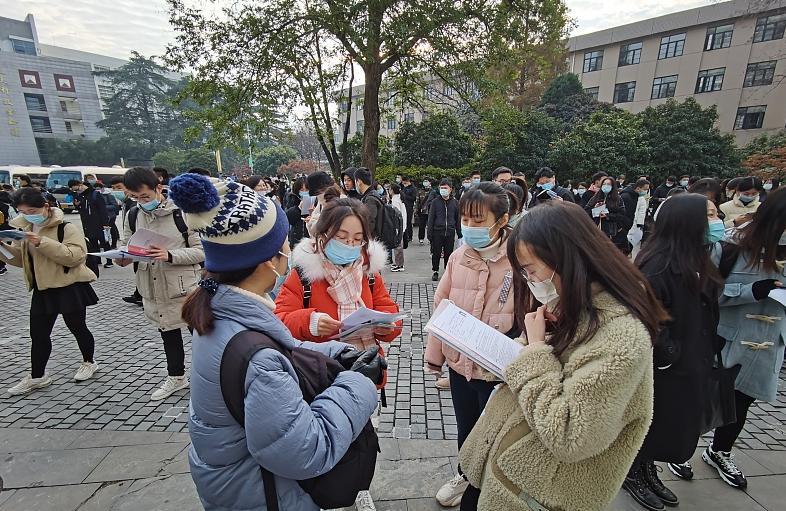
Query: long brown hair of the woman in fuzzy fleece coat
507,201,669,355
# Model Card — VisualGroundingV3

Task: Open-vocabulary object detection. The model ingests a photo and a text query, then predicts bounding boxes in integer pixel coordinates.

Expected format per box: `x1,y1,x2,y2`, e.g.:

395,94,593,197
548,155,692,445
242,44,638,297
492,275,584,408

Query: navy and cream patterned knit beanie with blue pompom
168,174,289,273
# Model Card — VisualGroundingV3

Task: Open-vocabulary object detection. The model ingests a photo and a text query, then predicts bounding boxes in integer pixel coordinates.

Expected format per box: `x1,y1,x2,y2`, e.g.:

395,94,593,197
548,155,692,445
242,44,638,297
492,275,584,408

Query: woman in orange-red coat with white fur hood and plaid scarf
276,199,401,350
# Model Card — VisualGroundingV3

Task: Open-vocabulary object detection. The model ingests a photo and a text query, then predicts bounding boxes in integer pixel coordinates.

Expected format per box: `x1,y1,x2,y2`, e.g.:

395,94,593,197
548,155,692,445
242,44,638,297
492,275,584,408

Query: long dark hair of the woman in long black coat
636,193,721,292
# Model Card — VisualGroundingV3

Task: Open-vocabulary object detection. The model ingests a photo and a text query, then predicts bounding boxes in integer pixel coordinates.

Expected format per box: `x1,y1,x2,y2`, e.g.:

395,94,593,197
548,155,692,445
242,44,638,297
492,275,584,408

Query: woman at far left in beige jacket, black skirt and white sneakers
0,188,98,395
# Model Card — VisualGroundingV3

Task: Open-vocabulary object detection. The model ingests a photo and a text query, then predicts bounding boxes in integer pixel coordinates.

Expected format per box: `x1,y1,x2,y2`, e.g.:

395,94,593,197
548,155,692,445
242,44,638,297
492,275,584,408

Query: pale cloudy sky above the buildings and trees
0,0,713,62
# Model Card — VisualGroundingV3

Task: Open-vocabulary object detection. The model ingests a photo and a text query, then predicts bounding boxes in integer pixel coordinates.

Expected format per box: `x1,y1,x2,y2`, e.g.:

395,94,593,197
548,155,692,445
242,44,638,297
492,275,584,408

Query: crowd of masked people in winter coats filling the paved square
0,167,786,511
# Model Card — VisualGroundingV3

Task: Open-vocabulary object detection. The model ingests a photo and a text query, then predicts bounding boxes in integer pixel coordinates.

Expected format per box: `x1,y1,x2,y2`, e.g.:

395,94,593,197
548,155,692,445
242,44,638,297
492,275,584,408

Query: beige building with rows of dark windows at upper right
568,0,786,145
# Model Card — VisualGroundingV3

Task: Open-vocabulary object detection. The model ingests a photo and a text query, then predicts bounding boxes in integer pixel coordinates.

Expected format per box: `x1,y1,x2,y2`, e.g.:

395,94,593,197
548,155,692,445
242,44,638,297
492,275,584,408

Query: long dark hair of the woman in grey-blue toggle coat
737,188,786,272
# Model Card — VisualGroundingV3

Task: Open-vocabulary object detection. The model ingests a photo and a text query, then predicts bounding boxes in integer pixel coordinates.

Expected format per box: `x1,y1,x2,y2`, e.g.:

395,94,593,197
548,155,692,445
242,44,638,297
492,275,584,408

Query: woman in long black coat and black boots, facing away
623,193,724,511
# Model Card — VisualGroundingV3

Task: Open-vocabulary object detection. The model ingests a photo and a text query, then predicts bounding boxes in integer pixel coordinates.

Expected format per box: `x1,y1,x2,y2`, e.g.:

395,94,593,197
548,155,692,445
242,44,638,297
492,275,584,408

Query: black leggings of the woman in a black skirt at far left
30,309,95,378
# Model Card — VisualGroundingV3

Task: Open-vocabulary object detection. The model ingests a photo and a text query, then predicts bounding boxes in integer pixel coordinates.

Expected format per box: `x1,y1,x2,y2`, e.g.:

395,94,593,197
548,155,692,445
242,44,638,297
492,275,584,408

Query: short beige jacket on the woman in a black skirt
0,208,96,291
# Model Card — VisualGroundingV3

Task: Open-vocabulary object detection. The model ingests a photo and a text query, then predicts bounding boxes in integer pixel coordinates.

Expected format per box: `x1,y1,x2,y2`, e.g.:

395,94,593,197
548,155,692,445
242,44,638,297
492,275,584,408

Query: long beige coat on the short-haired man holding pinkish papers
122,200,205,331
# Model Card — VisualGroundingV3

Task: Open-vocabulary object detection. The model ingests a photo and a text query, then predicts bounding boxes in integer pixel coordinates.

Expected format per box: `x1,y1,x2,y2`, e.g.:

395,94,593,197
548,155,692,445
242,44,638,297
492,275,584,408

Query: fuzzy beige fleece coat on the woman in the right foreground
460,292,653,511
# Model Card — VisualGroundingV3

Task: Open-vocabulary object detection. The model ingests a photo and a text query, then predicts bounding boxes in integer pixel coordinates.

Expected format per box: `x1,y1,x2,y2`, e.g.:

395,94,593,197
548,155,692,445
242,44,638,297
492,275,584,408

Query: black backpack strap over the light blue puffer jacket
219,330,291,511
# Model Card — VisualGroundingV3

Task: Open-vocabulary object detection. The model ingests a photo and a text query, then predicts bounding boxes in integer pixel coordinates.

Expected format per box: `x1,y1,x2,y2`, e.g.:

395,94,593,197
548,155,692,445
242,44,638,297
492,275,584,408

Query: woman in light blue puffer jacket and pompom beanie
169,175,377,511
